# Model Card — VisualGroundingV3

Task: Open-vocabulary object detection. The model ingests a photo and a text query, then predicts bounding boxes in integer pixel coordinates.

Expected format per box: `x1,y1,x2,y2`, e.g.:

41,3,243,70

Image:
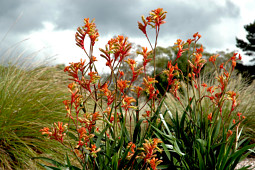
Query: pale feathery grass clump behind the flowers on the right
165,72,255,139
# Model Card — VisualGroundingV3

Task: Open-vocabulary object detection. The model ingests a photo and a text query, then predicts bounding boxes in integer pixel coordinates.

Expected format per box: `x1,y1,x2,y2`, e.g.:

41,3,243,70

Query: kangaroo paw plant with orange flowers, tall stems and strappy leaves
37,8,255,170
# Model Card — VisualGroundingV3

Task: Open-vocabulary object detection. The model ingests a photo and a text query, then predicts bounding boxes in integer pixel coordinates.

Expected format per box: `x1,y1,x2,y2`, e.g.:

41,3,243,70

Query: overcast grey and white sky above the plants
0,0,255,71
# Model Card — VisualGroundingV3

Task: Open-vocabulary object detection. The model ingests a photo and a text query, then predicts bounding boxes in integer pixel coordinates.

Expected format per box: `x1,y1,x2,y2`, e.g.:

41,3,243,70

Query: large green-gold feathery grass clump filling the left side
0,43,71,169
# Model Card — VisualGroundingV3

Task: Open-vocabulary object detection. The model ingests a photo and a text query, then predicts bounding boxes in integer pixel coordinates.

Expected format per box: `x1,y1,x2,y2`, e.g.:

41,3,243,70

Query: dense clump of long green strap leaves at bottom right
151,101,255,170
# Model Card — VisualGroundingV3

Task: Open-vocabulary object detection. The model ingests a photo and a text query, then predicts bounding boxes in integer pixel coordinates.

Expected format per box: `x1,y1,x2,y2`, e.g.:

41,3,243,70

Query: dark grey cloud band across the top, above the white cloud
0,0,240,49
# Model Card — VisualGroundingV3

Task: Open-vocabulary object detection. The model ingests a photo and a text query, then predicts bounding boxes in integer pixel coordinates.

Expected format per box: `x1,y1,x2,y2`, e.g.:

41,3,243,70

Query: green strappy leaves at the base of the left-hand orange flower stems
33,110,163,170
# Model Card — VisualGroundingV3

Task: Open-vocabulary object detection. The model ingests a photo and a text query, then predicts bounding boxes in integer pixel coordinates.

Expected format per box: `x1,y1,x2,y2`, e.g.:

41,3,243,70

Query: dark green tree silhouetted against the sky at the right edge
236,20,255,61
